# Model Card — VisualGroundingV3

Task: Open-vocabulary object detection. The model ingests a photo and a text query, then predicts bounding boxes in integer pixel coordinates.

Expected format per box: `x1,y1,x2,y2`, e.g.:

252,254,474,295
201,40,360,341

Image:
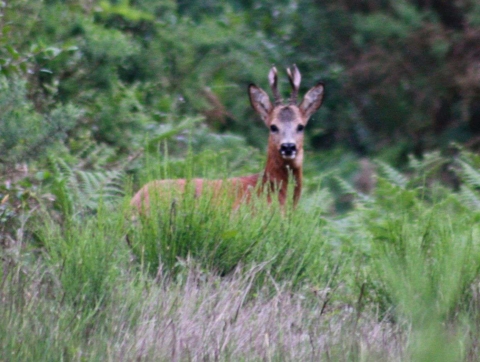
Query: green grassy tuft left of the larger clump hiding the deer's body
40,205,125,311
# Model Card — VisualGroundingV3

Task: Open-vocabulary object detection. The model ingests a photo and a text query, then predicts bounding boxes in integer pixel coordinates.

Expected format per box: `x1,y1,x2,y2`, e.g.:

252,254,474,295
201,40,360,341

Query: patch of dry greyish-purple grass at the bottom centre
115,267,405,361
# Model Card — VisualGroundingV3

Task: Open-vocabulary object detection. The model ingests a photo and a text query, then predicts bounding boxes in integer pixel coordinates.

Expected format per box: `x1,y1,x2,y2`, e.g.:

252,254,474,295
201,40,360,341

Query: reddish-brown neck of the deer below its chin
262,146,303,205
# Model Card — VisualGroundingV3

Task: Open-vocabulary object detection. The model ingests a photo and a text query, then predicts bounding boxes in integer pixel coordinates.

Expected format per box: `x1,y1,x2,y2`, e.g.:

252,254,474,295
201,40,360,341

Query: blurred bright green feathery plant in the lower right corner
374,205,472,360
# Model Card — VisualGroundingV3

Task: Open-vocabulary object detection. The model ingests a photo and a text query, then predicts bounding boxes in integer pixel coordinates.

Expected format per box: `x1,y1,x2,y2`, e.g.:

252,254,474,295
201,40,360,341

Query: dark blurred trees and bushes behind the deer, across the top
0,0,480,163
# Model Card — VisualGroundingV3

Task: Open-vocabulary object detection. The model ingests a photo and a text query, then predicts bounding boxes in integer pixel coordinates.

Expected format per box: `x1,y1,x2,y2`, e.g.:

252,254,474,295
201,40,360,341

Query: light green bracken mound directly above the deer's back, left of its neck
133,118,265,183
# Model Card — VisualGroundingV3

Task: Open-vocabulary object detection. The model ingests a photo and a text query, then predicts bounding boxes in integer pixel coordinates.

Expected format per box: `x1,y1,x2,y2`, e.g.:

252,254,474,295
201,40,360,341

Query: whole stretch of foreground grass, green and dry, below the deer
0,149,480,361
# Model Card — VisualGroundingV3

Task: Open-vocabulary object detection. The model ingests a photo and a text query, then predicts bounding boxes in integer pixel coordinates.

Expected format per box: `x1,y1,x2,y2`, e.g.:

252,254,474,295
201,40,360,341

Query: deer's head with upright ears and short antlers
248,65,325,167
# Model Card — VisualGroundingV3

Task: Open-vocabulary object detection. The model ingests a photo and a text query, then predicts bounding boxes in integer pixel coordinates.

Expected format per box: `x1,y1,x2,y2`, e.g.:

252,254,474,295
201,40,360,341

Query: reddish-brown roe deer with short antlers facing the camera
130,65,324,212
